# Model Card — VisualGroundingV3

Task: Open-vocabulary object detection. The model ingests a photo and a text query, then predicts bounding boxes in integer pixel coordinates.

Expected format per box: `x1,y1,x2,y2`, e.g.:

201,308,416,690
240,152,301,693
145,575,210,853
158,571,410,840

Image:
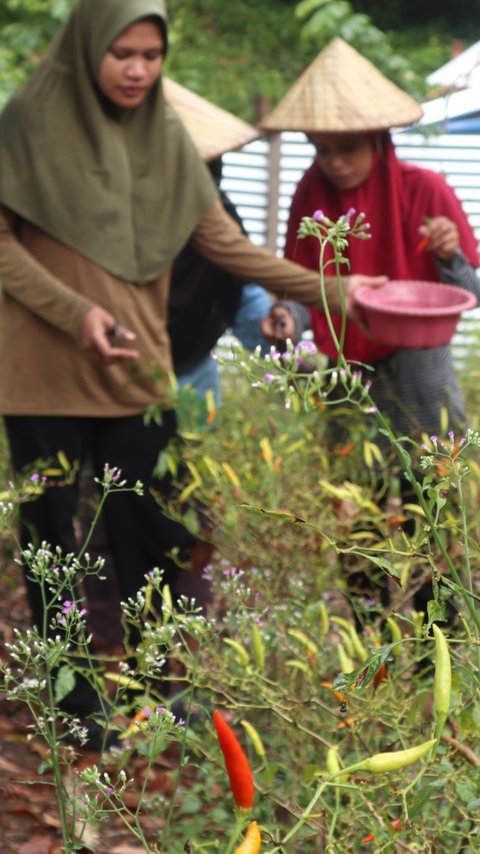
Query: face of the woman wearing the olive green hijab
98,21,165,107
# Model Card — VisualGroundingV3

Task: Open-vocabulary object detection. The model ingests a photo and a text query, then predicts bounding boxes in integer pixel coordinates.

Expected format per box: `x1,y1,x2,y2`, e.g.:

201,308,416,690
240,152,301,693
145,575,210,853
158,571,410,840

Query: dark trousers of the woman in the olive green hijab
5,411,192,626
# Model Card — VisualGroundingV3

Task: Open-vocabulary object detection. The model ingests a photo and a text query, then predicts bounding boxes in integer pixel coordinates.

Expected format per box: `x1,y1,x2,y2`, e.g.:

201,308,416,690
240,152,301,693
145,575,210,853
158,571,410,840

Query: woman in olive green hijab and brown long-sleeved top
0,0,384,736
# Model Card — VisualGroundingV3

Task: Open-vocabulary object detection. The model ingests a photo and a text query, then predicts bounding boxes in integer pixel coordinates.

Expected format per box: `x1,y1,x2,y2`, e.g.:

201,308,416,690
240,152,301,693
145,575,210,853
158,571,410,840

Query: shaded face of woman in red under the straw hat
309,133,373,190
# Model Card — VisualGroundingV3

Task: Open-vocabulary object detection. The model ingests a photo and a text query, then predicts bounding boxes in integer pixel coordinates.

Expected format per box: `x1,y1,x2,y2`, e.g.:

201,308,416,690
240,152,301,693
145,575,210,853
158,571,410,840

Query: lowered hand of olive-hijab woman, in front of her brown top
77,305,140,365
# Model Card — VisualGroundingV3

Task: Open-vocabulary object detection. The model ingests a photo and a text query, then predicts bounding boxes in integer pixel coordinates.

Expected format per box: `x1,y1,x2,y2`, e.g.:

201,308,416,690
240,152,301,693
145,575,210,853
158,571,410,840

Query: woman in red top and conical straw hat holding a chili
262,38,480,610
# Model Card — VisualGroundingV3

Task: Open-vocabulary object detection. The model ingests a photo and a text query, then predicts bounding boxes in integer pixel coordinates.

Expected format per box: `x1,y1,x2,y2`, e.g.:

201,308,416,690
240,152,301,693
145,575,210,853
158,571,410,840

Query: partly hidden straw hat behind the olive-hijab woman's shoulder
163,77,260,160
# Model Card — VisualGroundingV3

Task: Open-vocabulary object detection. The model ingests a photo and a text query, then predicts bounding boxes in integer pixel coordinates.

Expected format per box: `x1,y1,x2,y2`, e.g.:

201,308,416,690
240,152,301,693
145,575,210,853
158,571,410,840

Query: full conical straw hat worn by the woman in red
259,37,423,133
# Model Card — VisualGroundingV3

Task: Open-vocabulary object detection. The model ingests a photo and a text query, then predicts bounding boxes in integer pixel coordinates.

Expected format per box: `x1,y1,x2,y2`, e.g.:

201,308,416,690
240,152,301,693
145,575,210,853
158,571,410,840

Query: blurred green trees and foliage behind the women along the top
0,0,478,121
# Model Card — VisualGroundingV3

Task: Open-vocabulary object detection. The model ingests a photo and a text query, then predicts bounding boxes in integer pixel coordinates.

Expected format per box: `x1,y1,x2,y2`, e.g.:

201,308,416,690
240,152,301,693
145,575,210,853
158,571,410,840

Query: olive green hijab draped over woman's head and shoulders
0,0,216,284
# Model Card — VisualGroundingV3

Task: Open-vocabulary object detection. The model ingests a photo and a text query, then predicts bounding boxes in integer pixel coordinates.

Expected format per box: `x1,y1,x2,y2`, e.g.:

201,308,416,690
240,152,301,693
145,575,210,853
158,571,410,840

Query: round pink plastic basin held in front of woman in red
354,280,477,348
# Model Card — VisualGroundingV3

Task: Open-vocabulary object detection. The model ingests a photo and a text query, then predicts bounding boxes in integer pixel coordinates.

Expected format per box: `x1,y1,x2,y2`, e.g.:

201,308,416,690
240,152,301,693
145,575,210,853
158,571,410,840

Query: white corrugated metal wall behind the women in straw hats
222,132,480,359
